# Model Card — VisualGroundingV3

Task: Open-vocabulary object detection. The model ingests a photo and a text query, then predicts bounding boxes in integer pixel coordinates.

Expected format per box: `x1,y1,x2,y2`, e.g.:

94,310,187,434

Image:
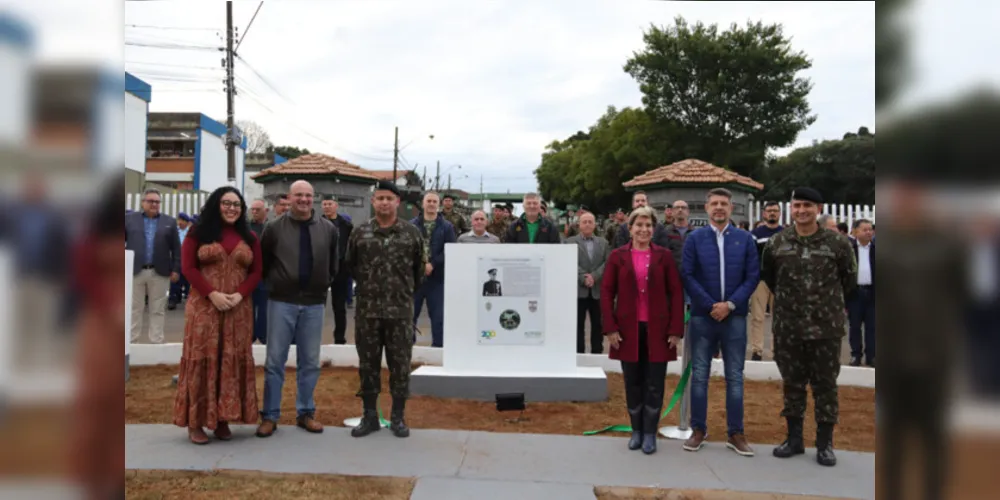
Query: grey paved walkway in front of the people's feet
125,425,875,500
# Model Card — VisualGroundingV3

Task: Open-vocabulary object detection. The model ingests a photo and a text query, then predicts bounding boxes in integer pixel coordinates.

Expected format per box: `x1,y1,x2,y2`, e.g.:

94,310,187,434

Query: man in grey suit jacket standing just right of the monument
566,212,611,354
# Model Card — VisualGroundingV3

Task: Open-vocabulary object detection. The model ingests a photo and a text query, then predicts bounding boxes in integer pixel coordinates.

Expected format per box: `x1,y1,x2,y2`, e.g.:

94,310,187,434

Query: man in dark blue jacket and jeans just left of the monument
410,192,455,347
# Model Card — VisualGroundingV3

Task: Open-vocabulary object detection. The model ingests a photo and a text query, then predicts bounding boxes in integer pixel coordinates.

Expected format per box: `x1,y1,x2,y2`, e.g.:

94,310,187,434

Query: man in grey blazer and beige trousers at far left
125,189,181,344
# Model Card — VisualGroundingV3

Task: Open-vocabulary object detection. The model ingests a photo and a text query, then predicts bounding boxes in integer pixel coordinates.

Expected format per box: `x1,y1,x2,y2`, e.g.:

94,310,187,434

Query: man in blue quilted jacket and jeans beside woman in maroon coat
681,188,760,457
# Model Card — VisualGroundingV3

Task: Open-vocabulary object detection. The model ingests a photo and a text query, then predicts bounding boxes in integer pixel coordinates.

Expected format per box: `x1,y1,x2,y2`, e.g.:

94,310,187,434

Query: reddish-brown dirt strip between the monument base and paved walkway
125,366,876,452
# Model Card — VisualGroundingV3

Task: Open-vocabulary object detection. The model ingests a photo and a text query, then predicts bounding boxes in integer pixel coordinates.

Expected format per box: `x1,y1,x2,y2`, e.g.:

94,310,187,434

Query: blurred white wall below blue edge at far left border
0,42,31,145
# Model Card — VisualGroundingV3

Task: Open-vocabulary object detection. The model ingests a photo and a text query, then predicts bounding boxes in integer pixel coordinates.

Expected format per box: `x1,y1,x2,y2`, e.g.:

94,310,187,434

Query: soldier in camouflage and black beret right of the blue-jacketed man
761,188,858,466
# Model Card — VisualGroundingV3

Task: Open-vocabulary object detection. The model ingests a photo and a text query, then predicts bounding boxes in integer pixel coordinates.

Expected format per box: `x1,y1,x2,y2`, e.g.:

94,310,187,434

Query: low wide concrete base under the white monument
410,366,608,403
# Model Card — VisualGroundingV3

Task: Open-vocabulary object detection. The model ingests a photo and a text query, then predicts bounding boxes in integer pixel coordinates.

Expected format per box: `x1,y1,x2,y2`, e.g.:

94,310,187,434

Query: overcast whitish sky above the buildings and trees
17,0,1000,192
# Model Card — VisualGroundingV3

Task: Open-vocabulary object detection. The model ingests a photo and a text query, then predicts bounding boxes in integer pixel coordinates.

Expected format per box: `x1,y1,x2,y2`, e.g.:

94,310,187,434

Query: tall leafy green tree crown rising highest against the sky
624,17,816,175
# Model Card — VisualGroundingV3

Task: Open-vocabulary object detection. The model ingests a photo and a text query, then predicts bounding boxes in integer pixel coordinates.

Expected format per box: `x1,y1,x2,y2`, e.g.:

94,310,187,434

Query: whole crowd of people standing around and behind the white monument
126,181,874,465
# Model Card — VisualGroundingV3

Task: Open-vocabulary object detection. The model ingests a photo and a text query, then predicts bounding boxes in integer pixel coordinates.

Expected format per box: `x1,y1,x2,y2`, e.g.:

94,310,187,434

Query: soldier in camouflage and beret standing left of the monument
347,182,426,438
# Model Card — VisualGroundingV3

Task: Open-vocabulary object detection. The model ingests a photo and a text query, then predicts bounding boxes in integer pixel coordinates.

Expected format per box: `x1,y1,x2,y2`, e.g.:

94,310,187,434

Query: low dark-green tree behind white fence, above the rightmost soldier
760,131,875,205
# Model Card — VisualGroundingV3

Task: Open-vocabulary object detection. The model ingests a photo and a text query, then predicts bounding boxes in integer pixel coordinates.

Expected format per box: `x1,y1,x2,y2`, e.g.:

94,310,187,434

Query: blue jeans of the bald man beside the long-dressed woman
260,300,326,422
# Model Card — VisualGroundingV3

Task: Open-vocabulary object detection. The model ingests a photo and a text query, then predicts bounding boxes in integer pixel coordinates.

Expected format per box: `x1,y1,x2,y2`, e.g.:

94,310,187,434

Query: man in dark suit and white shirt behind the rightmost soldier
847,219,875,368
